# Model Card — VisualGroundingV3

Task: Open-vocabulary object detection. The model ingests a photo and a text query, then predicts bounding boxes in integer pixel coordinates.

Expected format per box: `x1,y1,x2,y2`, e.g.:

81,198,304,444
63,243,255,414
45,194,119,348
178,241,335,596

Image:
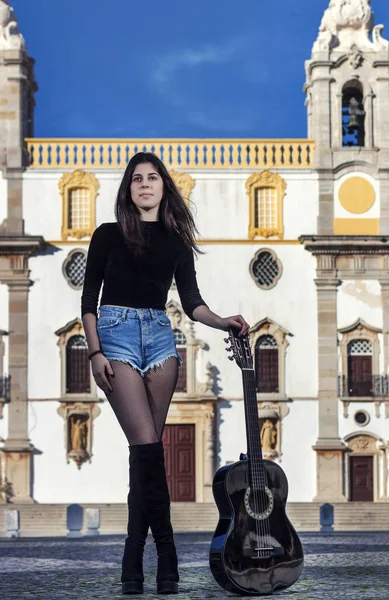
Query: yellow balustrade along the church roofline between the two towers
26,138,315,169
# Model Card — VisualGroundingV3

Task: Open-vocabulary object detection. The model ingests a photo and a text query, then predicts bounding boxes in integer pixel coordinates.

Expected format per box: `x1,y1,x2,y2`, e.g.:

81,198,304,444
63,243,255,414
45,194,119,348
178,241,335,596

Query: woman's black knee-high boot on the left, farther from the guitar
121,447,149,594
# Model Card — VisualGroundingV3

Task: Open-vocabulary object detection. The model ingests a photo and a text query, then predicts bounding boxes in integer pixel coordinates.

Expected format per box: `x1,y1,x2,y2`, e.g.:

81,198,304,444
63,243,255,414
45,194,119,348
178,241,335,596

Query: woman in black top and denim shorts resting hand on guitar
82,152,249,594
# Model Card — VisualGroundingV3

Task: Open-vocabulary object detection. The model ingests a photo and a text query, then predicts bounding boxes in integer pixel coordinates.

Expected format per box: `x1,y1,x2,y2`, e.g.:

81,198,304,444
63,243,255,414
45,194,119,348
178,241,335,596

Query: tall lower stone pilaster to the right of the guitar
314,276,346,502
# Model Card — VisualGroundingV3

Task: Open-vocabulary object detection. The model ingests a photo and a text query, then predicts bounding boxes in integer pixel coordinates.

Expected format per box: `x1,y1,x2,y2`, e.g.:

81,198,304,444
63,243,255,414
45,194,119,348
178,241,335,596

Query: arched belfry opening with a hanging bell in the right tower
342,80,365,147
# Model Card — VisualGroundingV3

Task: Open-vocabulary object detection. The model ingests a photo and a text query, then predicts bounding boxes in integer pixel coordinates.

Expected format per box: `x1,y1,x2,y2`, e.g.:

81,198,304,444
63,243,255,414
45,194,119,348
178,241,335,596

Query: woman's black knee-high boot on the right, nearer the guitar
132,442,179,594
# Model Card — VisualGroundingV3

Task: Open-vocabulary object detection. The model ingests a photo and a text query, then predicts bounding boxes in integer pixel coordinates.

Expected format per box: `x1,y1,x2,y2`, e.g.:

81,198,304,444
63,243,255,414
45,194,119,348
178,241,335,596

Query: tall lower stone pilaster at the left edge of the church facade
2,274,33,503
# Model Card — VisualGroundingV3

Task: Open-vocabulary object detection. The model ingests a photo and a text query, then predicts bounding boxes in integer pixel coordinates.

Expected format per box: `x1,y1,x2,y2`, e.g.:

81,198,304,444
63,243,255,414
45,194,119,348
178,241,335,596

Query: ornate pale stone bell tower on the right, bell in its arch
305,0,389,235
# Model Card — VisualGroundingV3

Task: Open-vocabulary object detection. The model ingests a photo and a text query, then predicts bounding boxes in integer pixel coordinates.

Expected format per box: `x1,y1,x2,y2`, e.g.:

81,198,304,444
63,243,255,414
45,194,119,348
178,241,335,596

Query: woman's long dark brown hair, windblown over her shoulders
115,152,203,254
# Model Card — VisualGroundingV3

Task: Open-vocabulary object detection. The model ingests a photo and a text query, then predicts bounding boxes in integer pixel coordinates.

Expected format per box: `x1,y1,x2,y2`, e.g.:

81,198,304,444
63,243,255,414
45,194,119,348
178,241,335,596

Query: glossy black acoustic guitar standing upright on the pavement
209,330,304,595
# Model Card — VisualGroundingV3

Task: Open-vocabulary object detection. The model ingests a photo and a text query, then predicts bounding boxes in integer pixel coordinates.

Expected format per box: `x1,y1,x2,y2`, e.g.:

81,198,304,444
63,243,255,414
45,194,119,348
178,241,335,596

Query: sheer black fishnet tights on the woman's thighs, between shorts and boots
107,356,178,446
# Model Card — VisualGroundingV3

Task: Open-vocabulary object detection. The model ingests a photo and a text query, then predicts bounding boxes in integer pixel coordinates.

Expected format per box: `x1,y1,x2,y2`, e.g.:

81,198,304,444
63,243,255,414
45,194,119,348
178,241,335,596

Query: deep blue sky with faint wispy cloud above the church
16,0,389,138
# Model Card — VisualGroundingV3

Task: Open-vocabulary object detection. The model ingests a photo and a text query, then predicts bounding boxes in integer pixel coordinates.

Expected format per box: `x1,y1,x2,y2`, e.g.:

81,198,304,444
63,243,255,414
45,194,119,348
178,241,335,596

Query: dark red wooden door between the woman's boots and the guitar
162,425,196,502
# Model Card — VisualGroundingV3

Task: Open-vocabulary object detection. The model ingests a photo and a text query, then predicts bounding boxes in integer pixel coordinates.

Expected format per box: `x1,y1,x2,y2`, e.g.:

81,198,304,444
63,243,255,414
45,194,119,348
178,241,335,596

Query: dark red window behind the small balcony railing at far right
347,340,373,397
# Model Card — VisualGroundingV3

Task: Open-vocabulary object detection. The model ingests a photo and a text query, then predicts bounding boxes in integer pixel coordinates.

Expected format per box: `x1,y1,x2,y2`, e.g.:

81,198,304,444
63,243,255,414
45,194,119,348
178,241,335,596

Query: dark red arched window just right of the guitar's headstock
255,335,279,394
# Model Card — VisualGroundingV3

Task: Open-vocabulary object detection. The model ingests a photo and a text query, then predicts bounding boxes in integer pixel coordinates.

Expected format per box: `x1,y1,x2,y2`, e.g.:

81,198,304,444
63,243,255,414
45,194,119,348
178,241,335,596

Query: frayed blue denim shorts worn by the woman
97,305,182,377
